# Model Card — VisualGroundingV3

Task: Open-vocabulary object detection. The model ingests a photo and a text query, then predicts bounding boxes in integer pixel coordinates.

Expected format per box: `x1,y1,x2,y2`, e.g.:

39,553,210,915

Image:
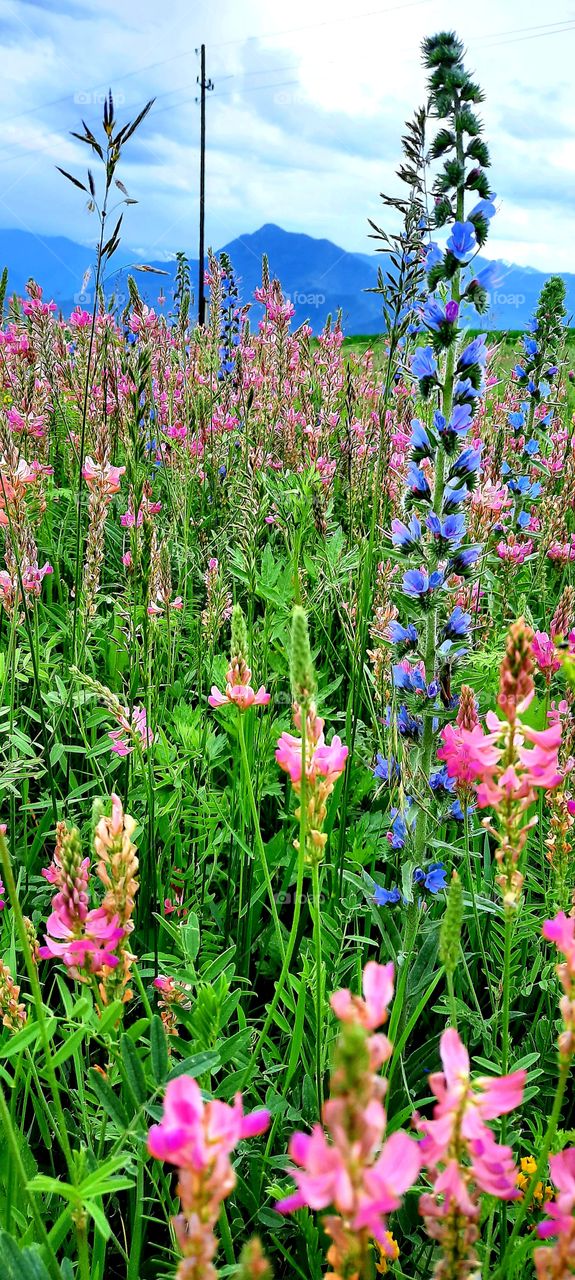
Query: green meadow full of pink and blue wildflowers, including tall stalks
0,33,575,1280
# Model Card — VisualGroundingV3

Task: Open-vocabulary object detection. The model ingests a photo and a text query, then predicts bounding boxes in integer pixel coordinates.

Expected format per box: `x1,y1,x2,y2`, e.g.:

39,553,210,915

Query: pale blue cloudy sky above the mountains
0,0,575,271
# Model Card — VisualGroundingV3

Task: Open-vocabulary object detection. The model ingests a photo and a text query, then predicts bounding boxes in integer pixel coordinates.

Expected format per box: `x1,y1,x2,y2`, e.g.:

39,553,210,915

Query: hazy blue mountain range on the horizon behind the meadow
0,223,575,334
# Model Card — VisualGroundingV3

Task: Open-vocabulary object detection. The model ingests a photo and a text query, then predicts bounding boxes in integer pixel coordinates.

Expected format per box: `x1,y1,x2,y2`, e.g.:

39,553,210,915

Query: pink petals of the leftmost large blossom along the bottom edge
147,1075,270,1172
